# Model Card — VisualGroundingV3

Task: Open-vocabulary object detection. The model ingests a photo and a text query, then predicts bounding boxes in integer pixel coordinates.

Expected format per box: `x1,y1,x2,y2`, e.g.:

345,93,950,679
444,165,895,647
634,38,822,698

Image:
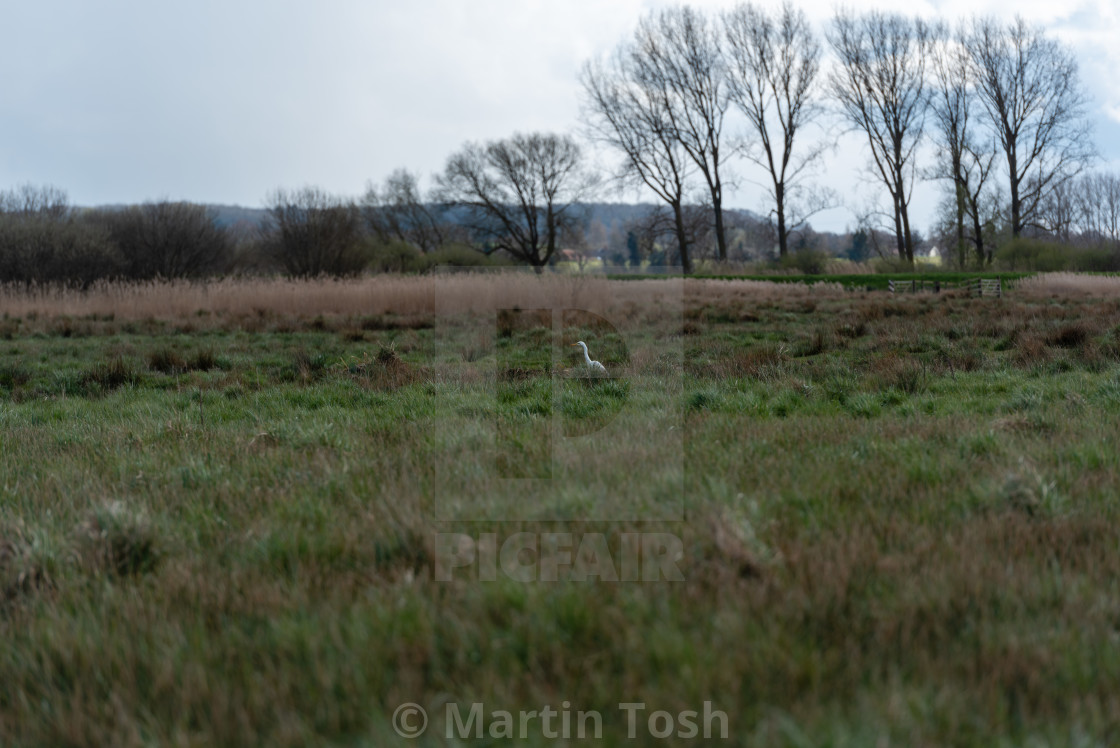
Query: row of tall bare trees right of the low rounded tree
582,2,1110,271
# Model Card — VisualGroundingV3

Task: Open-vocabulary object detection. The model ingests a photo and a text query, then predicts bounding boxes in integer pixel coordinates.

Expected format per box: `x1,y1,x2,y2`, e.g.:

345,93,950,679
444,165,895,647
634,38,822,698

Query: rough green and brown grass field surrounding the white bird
0,274,1120,746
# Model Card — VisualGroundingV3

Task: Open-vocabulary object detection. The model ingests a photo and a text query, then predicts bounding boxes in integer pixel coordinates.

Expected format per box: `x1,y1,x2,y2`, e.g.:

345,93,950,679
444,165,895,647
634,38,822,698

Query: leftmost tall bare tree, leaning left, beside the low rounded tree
580,50,694,274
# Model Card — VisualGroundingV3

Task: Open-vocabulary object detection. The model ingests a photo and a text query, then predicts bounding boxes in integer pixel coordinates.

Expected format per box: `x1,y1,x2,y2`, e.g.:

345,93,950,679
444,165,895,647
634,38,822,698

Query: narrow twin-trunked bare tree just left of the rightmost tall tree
930,25,996,268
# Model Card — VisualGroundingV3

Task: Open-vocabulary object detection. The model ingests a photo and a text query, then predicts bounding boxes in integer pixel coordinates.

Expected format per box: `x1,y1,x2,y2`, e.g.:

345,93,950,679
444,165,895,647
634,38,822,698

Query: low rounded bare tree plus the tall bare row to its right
374,2,1102,272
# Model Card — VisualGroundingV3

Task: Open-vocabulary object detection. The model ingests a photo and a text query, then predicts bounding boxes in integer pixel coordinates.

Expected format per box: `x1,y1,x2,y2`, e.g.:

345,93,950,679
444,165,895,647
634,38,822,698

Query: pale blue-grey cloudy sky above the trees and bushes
0,0,1120,231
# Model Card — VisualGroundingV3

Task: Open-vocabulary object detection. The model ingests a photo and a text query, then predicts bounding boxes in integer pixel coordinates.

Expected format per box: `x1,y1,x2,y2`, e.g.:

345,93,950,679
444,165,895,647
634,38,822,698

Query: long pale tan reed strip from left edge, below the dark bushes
0,272,842,320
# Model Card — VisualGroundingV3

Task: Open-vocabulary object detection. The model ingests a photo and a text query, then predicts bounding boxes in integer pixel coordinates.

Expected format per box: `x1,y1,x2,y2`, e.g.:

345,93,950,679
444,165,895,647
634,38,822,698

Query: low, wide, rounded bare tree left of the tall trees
437,133,595,270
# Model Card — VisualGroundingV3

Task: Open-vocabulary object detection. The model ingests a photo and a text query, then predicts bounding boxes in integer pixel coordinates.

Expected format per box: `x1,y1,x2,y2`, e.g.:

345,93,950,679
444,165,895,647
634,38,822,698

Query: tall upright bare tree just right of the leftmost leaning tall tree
632,6,729,262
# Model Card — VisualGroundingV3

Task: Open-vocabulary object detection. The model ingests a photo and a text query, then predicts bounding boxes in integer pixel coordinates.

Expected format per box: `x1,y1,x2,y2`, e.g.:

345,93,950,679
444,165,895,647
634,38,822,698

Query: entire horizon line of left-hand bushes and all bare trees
0,2,1120,279
